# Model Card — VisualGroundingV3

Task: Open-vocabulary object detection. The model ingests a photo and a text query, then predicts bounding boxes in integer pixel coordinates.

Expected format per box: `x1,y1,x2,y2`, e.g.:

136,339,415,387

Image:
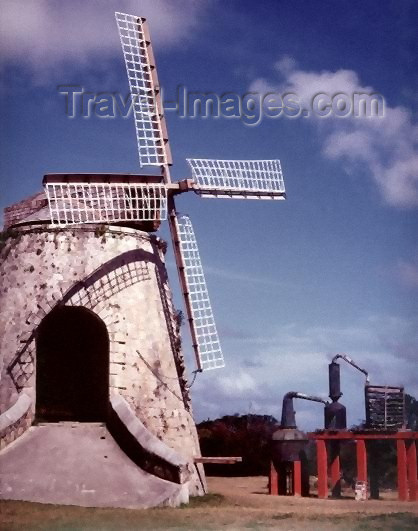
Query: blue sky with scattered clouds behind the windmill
0,0,418,428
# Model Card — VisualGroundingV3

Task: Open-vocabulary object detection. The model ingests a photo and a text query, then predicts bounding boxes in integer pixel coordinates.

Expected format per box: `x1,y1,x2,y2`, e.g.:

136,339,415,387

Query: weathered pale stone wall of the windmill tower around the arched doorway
0,226,199,470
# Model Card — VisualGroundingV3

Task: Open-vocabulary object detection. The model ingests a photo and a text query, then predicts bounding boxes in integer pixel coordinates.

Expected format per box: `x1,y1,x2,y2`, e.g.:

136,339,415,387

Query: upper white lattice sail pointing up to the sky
115,12,172,168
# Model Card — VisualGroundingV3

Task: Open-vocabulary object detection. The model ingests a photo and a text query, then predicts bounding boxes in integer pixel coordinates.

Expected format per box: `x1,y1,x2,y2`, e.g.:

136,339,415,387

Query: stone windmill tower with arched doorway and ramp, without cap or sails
0,224,205,507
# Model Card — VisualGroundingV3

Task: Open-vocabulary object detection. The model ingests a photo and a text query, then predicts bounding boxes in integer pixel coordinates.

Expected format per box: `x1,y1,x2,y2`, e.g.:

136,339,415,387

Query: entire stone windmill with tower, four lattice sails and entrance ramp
0,13,285,507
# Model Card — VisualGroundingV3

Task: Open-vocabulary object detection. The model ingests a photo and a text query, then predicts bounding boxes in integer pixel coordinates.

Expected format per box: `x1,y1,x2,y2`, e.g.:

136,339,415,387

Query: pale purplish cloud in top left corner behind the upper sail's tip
0,0,206,78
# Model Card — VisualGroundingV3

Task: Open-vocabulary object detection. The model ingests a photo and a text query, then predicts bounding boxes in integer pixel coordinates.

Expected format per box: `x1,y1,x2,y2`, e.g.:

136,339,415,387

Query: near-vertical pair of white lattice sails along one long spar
115,13,224,370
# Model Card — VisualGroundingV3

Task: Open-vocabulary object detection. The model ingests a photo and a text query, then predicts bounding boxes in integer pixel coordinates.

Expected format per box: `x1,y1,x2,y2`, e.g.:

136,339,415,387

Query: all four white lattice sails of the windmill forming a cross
44,12,286,371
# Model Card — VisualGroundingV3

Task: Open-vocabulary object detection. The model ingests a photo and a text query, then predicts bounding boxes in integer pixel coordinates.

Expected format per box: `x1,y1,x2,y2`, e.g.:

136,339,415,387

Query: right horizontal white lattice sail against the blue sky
187,159,286,199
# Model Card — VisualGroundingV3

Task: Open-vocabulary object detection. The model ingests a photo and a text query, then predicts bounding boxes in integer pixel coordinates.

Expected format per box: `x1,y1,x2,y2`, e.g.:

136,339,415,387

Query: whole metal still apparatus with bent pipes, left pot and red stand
270,354,418,501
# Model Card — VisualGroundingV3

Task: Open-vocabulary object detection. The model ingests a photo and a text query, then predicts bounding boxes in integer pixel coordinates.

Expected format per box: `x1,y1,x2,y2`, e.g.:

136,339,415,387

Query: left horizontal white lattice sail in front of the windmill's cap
44,182,167,226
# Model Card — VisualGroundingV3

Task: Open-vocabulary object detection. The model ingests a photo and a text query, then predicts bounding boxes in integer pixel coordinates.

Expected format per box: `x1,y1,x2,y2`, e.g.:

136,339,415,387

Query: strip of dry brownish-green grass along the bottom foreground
0,494,418,531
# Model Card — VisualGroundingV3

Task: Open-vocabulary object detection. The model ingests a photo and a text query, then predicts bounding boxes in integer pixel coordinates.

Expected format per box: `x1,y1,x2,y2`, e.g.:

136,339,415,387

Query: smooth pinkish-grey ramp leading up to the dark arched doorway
0,422,188,508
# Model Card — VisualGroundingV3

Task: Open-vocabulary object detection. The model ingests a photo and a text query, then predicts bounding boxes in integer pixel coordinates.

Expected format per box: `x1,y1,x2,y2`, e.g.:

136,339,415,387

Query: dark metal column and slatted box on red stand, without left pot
308,354,417,501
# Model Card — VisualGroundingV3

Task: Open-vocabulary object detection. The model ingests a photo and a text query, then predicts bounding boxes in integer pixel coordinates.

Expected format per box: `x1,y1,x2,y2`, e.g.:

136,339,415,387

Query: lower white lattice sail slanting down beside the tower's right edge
177,216,225,371
